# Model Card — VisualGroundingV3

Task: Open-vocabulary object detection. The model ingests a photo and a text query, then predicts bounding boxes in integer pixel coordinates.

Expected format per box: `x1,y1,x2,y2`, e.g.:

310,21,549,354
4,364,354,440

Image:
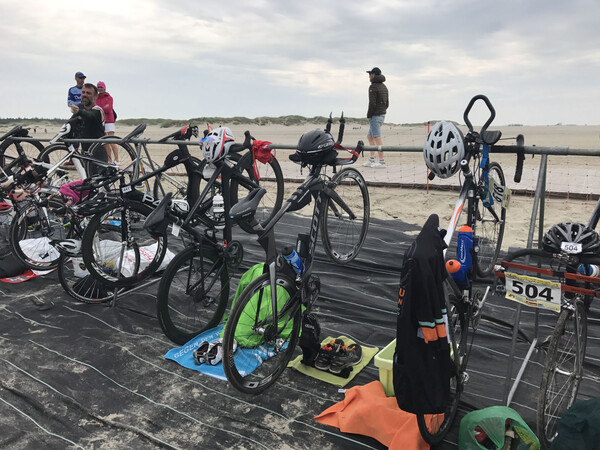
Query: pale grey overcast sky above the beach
0,0,600,125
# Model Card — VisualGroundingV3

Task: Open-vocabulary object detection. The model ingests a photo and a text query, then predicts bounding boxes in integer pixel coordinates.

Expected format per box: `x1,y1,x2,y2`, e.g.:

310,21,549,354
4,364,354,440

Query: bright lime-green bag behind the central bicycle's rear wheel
221,263,293,348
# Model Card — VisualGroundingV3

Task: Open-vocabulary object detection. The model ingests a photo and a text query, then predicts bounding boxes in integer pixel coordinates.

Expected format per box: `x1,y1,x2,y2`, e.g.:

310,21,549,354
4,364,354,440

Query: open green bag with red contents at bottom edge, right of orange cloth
458,406,540,450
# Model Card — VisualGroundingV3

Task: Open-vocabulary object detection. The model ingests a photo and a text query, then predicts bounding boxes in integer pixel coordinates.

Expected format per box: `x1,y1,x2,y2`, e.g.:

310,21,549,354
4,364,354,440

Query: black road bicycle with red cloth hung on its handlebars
154,132,283,345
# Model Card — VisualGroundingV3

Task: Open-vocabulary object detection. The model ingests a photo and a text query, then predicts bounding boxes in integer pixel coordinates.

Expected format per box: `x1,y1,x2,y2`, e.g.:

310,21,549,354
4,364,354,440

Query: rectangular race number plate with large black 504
504,272,561,311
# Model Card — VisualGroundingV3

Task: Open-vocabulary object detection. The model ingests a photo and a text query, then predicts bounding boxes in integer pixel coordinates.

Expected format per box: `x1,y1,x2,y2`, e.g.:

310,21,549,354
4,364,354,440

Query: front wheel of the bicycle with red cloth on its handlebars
231,152,283,233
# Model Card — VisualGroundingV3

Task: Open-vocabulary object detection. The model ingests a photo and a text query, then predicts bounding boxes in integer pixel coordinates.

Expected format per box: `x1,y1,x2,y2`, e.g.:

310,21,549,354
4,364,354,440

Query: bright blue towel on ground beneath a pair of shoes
165,324,284,380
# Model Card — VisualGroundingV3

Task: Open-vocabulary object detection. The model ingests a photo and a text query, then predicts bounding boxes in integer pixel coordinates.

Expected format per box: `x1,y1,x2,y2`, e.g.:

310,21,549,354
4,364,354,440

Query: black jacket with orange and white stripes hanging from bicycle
393,214,452,414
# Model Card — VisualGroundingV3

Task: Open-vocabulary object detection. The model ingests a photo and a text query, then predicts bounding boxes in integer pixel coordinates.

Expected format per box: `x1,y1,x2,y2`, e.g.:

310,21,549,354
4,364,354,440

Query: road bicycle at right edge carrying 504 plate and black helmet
495,222,600,449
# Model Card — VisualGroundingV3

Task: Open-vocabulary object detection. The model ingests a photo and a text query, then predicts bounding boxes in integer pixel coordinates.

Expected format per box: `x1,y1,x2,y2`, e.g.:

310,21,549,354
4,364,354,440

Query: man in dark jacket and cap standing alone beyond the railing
364,67,390,168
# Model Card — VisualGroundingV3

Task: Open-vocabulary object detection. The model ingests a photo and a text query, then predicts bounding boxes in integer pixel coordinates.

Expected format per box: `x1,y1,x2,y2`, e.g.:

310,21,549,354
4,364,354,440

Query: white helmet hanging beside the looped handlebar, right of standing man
423,121,465,178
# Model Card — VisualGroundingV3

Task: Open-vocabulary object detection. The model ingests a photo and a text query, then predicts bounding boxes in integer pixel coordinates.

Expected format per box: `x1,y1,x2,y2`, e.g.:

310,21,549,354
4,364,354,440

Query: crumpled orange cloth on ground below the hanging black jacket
315,381,429,450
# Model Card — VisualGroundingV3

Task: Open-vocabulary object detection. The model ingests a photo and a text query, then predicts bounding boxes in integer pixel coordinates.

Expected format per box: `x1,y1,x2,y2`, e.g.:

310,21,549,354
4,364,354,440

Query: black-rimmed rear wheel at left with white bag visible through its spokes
81,202,167,287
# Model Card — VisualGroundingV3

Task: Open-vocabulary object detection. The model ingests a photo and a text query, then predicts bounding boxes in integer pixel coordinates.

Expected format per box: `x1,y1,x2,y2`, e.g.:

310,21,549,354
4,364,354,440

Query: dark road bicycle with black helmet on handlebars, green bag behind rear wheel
223,117,370,394
